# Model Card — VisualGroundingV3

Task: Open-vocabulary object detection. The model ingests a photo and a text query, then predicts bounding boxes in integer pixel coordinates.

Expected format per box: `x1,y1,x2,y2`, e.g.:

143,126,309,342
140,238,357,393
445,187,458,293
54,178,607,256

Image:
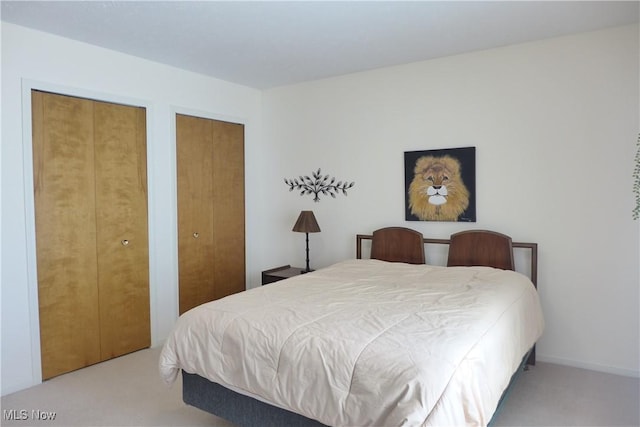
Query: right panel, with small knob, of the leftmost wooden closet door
95,102,151,360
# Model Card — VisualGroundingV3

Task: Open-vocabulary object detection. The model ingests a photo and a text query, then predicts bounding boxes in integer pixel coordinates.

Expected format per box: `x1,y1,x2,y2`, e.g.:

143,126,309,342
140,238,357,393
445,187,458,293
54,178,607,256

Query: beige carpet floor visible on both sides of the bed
0,348,640,427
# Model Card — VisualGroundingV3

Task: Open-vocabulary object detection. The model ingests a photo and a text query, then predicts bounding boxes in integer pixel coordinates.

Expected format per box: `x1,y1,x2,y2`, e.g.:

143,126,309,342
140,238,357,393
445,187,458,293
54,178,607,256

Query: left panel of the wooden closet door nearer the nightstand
176,114,215,314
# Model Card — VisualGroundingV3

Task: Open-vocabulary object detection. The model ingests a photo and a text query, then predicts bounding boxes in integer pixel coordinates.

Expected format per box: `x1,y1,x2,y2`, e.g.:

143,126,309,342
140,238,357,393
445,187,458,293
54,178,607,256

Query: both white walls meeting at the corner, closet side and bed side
1,22,640,394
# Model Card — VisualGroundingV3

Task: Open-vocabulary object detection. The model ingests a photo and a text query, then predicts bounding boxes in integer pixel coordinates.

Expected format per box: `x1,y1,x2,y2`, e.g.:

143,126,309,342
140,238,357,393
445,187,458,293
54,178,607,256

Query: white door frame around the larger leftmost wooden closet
21,79,161,383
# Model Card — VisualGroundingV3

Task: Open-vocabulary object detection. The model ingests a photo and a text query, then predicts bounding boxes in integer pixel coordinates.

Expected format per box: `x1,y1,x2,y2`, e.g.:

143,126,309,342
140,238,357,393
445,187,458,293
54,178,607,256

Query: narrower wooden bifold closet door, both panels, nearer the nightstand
176,114,245,314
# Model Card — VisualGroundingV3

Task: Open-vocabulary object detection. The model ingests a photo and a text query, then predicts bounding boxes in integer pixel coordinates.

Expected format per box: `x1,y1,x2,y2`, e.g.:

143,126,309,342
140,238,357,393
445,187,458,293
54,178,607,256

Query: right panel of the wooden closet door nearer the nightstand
212,120,245,298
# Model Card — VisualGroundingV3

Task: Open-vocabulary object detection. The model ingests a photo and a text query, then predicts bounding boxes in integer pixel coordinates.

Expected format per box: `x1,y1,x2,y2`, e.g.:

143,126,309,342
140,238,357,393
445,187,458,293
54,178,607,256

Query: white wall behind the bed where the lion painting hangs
260,26,640,376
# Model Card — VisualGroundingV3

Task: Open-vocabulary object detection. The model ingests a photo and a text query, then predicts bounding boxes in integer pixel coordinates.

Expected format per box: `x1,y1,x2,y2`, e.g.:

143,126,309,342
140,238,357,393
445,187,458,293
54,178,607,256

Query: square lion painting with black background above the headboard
404,147,476,222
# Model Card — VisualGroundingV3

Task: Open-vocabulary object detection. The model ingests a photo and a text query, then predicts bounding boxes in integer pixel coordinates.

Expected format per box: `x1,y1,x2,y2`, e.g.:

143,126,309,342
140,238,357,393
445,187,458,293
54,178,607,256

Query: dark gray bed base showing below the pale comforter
182,353,529,427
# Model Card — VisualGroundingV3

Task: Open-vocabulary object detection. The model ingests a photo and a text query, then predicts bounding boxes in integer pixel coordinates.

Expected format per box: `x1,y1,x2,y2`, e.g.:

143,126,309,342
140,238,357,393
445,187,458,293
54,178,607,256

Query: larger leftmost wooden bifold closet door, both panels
32,91,150,379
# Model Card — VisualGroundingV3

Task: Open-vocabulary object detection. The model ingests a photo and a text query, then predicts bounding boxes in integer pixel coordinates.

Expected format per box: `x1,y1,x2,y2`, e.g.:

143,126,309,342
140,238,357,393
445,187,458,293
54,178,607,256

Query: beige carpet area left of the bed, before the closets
1,348,231,427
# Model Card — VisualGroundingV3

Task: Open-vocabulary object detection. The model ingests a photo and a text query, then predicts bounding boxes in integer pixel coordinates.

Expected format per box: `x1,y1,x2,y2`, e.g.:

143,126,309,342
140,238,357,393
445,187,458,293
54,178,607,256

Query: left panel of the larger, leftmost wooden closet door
32,91,100,379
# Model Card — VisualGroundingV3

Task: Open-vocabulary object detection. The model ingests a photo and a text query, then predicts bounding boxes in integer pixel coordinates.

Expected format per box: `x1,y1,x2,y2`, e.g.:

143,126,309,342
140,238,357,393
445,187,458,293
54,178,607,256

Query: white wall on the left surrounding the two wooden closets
1,22,263,395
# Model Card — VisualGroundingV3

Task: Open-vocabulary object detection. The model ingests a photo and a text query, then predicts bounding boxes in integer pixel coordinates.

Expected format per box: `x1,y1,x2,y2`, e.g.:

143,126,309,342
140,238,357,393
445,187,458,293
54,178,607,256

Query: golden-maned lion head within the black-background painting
408,155,469,221
